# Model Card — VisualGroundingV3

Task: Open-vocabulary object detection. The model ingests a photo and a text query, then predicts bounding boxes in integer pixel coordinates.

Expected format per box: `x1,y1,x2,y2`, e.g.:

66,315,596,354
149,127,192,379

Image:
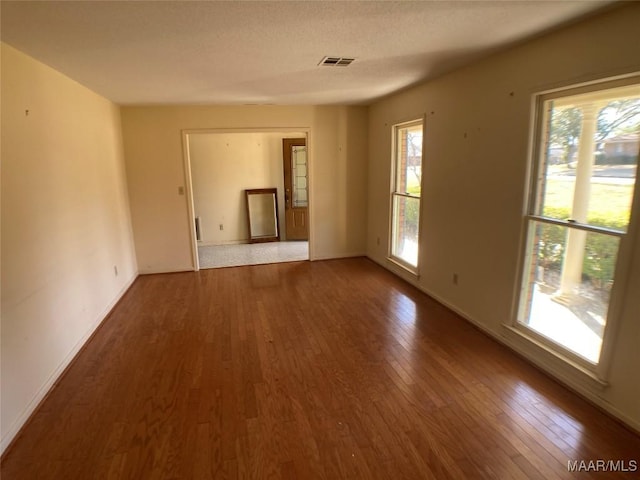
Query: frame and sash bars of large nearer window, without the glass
506,73,640,387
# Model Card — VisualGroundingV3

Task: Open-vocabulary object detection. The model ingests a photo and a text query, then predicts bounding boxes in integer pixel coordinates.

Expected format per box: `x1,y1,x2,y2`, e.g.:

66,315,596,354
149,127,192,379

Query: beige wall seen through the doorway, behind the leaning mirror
189,132,306,245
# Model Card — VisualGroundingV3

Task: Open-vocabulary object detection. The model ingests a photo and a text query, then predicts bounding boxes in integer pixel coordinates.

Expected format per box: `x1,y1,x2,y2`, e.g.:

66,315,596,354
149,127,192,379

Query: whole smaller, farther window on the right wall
390,120,422,273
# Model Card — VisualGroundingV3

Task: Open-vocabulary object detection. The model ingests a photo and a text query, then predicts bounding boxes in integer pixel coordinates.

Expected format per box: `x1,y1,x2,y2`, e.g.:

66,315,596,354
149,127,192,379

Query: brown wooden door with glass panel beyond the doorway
282,138,309,240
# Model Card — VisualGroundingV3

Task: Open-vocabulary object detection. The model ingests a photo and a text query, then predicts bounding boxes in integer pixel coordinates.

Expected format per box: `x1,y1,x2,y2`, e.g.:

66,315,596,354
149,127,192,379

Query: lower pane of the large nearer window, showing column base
520,220,620,363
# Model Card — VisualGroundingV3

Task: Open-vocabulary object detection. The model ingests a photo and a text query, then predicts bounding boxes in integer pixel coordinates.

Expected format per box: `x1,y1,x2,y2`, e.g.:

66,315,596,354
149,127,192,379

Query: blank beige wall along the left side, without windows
1,44,137,450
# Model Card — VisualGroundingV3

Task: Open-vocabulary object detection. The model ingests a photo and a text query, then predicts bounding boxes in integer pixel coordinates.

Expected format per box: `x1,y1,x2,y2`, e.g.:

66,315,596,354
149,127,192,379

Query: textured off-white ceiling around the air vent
0,0,610,104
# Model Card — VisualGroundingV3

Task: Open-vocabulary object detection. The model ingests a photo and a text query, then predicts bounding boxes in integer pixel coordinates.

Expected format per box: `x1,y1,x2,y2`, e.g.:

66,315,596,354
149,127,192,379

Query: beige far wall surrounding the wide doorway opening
122,106,367,273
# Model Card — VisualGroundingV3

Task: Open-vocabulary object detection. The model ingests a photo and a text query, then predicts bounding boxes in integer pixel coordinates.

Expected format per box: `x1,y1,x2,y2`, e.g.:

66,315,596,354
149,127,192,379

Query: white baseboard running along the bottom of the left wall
0,272,138,455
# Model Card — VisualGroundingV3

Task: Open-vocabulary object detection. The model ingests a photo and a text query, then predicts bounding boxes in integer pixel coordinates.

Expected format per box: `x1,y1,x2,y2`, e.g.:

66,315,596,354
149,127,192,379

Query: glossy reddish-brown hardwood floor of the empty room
1,259,640,480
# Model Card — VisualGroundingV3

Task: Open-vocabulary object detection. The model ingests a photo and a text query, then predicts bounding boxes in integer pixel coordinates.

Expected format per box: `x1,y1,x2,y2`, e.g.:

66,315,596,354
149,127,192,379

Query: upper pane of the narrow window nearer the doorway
395,124,422,196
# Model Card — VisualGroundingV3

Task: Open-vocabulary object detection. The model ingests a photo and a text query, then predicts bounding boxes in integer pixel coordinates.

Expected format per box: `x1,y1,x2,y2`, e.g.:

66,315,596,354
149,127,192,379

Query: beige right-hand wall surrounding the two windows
367,4,640,428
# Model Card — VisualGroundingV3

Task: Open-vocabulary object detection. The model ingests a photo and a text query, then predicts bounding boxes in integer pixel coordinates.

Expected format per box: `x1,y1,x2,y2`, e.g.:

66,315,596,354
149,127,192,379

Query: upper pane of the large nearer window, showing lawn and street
534,93,640,231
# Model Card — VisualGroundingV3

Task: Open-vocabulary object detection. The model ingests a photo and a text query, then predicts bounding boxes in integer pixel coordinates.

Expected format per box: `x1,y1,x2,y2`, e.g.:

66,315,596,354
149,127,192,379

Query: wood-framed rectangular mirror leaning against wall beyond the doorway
245,188,280,243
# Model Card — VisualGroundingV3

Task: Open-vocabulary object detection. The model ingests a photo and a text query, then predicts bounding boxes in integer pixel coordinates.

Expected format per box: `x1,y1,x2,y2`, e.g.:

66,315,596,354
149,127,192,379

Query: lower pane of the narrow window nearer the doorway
391,194,420,267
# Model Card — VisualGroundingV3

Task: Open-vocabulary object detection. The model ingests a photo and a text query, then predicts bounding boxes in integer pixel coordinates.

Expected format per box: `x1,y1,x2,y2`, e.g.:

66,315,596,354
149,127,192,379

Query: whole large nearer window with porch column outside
516,77,640,373
